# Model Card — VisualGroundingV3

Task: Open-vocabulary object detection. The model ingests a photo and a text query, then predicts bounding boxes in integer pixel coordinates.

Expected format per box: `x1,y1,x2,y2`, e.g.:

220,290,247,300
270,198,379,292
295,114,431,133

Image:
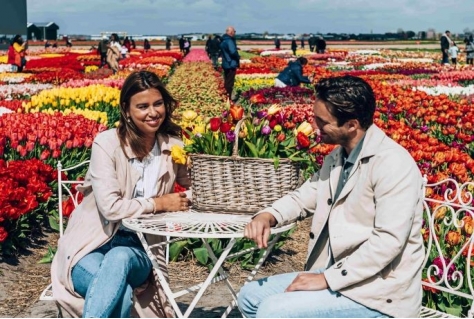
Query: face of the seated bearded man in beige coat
312,99,350,146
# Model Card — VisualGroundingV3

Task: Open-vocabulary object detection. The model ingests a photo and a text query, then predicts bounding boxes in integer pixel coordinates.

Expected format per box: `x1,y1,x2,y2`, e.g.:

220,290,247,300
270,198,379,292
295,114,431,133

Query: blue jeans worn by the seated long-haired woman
72,230,152,318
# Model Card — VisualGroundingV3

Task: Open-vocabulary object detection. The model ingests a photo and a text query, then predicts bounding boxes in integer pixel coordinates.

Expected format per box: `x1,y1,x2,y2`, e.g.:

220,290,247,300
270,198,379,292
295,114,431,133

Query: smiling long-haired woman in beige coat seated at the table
51,71,191,318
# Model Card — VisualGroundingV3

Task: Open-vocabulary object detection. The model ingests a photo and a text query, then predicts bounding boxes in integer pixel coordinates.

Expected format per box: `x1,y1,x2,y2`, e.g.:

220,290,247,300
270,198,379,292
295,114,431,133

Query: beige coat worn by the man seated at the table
262,125,424,318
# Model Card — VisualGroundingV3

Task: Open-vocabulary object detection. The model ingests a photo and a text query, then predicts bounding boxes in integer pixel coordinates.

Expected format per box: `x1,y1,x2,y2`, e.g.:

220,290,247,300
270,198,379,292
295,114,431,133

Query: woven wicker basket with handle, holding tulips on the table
189,119,300,214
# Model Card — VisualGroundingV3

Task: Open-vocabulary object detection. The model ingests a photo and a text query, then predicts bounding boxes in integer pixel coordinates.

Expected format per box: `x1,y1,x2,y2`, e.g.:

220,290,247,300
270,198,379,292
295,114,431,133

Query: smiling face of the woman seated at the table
127,89,166,138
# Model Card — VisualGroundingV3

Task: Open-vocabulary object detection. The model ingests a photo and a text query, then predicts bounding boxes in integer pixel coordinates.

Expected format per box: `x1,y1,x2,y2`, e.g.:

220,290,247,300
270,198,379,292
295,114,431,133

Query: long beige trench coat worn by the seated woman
51,129,191,317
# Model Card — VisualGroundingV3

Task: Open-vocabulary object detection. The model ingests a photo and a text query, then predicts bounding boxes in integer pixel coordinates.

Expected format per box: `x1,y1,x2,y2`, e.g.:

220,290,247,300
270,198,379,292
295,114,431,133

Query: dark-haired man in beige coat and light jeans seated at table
239,76,424,318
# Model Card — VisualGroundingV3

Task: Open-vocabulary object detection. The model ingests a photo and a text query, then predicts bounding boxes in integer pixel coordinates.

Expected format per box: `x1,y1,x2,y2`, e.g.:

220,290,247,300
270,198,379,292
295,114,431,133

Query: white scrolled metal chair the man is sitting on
420,176,474,318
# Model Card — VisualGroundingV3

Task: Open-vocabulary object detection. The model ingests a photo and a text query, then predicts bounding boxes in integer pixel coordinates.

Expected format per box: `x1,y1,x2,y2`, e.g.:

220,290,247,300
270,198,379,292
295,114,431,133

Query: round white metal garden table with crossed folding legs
122,210,295,318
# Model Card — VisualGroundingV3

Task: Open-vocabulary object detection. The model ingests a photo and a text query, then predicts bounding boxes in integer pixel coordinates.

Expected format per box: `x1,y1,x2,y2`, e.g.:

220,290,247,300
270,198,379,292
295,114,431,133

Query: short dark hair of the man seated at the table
314,75,375,129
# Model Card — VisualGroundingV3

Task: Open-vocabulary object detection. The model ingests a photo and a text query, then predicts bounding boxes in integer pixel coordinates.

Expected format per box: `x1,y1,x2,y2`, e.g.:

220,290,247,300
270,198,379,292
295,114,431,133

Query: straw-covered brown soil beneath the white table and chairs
0,219,310,318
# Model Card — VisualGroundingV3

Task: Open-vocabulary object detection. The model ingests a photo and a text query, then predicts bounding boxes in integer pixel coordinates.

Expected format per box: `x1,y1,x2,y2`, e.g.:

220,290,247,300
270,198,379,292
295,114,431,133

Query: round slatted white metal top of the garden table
122,209,295,238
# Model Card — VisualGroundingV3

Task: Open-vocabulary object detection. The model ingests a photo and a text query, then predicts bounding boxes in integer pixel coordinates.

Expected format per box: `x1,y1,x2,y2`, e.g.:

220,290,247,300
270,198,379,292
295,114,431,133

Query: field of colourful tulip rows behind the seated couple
0,44,474,311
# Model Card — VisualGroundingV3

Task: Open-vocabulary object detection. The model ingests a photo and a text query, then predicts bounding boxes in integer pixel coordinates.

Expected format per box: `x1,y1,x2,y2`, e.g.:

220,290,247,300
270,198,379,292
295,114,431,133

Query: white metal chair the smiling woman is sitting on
39,160,90,317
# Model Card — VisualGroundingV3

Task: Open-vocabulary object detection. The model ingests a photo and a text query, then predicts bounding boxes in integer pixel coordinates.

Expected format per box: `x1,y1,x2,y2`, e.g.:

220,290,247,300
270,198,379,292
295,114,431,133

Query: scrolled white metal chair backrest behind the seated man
422,177,474,317
